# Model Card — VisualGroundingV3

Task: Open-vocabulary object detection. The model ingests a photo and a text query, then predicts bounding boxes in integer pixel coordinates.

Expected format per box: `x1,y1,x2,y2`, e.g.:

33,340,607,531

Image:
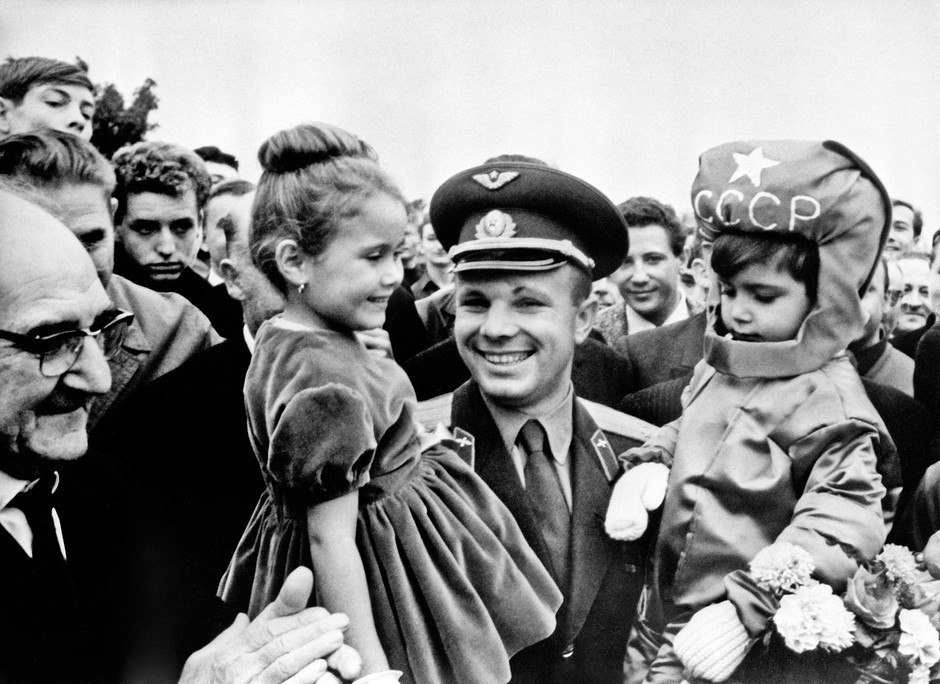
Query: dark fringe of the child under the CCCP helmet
711,232,819,302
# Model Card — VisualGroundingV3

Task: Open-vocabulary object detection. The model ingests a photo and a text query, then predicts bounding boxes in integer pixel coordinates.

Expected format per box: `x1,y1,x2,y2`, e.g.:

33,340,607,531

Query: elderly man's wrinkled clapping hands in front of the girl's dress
180,568,349,684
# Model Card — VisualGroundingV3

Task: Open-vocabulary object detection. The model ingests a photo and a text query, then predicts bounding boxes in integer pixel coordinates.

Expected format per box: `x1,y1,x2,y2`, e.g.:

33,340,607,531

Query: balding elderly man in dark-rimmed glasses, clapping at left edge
0,183,356,683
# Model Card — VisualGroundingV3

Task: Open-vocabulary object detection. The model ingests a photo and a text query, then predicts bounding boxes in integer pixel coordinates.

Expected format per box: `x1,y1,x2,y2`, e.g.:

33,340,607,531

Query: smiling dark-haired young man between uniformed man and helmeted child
595,192,689,351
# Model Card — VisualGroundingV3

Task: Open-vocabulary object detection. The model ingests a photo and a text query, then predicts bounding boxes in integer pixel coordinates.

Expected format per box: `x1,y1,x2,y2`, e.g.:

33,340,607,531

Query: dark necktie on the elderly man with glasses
9,478,72,598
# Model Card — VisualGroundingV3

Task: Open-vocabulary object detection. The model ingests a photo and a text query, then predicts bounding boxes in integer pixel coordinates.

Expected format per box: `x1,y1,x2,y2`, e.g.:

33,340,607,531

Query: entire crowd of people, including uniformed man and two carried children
0,57,940,684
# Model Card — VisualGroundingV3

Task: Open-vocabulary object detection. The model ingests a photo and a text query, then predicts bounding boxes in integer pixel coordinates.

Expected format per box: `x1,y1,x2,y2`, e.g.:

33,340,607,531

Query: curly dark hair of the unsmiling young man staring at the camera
111,141,212,225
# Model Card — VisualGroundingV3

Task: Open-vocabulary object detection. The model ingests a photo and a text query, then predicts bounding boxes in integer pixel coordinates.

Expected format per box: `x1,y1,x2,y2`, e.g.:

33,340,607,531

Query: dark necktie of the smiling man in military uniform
518,420,571,591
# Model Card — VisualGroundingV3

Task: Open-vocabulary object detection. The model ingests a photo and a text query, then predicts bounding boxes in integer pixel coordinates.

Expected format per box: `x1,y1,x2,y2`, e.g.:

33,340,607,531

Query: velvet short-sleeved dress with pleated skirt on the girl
220,318,561,684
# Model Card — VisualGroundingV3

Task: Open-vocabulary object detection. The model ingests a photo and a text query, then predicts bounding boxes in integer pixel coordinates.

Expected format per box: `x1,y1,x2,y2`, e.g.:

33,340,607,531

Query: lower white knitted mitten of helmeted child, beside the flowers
672,601,756,682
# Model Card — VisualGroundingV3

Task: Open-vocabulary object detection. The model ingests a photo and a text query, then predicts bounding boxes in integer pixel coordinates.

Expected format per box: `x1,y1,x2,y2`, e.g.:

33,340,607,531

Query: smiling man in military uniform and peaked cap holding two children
431,162,648,683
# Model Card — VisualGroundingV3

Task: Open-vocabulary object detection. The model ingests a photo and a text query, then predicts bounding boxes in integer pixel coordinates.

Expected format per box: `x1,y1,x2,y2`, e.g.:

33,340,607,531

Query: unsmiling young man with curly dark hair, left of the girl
113,142,230,328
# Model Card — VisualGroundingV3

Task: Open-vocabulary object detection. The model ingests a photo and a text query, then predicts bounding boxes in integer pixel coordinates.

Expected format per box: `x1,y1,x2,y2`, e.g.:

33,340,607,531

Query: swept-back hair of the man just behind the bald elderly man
0,130,115,200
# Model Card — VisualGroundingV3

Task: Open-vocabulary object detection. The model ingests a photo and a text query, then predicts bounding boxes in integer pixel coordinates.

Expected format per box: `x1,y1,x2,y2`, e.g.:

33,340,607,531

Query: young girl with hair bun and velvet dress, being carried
220,125,561,684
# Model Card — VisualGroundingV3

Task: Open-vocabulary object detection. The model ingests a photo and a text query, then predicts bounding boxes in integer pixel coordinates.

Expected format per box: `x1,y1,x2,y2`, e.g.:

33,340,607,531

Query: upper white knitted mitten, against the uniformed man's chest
604,463,669,541
